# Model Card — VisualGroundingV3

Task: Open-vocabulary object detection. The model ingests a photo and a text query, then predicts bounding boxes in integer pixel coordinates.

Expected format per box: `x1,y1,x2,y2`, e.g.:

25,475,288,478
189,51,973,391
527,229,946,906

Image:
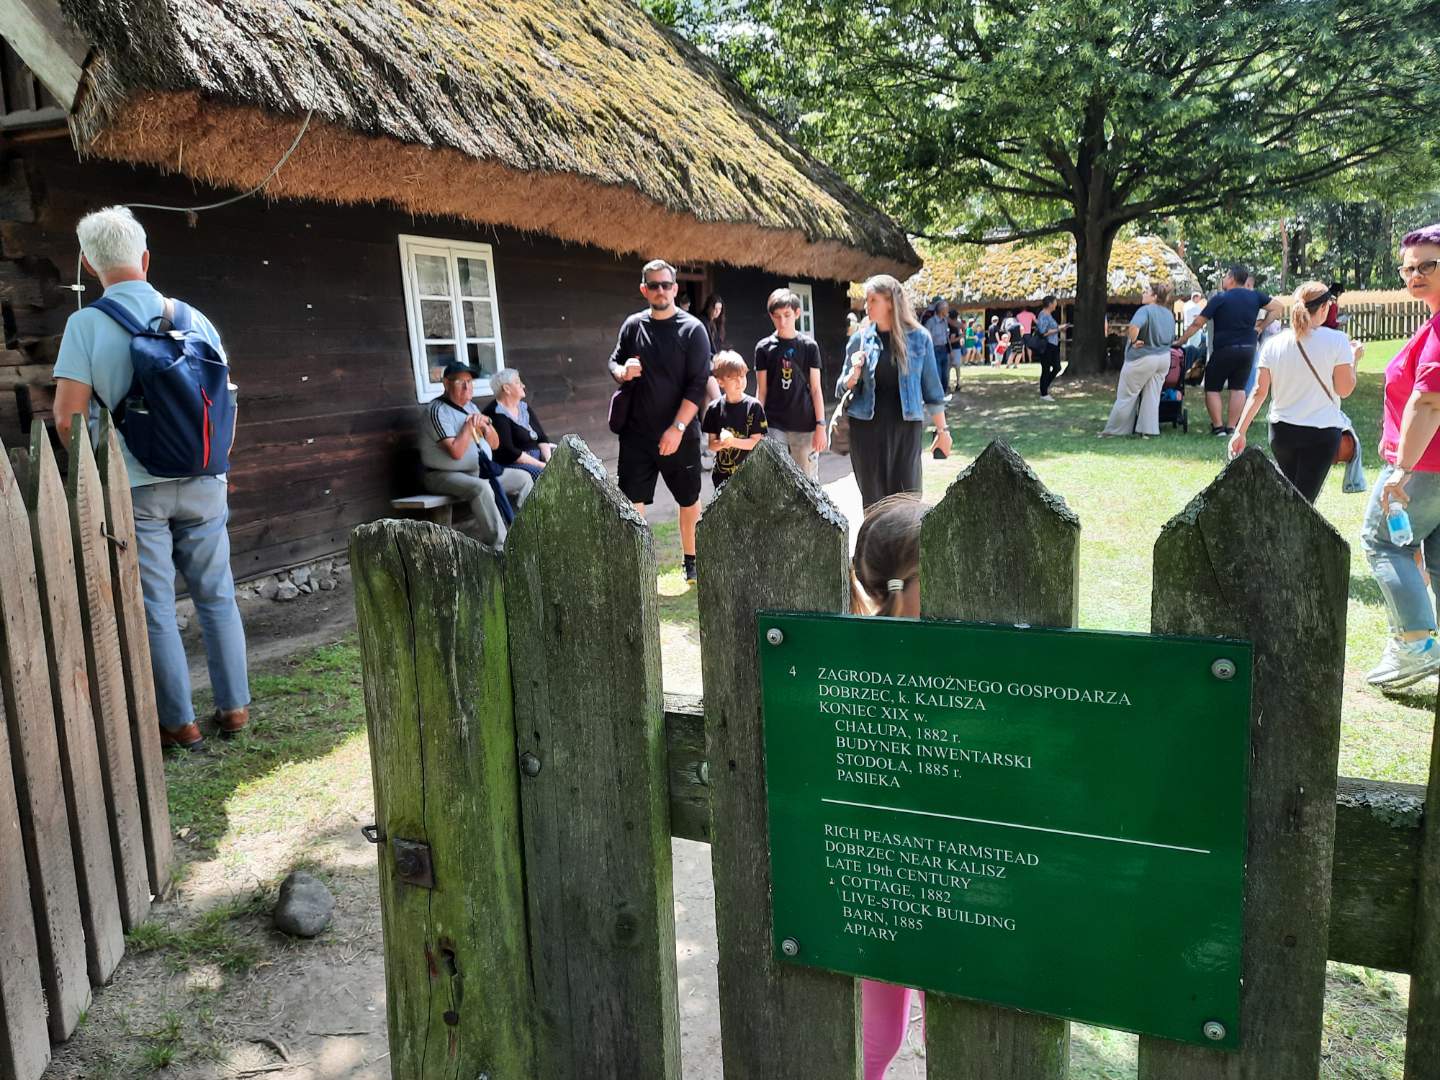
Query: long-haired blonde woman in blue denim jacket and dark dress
835,274,950,507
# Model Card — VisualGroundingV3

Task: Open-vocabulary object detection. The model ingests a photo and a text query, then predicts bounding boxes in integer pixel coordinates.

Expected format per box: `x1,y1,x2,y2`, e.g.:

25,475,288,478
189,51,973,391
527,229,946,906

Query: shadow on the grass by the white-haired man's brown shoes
166,635,364,851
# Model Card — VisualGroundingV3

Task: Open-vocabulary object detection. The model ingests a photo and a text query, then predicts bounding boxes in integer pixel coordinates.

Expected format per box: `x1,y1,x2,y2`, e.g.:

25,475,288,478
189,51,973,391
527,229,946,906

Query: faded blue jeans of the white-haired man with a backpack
130,477,251,730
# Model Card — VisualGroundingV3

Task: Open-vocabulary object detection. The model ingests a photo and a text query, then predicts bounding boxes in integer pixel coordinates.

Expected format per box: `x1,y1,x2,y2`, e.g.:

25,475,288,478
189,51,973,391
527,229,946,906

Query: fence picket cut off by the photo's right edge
1405,708,1440,1080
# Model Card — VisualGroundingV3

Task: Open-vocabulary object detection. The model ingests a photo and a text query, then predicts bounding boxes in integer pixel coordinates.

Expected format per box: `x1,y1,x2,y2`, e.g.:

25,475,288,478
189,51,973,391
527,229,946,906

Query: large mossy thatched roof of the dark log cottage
60,0,919,279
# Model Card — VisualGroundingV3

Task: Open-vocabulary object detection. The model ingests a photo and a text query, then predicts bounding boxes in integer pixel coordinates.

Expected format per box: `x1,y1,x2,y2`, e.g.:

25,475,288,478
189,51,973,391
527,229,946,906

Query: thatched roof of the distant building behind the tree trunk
906,236,1198,307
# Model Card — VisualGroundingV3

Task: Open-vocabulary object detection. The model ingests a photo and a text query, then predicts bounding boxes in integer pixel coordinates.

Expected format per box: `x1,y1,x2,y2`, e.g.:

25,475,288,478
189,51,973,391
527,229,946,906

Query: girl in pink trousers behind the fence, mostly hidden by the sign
850,494,929,1080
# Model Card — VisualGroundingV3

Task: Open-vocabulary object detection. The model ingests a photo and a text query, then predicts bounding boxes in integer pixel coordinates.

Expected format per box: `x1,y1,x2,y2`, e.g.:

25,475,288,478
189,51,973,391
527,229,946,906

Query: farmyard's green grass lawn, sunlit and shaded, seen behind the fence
154,343,1416,1080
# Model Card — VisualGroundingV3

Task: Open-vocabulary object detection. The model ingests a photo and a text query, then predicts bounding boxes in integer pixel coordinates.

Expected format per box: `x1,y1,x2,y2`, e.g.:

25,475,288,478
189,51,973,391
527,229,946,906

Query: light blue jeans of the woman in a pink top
1359,465,1440,634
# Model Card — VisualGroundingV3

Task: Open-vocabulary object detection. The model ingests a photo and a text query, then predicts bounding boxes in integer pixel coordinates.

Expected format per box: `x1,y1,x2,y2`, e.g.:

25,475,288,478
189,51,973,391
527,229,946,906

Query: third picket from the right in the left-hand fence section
23,422,125,986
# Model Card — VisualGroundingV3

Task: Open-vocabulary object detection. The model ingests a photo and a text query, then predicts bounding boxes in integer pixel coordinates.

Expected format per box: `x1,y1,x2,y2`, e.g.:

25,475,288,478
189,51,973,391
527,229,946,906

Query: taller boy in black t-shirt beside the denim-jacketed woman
755,289,825,480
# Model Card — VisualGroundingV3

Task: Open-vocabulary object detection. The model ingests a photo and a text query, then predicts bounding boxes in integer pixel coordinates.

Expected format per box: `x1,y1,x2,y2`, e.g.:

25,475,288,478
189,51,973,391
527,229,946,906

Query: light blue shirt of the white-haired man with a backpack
55,281,225,488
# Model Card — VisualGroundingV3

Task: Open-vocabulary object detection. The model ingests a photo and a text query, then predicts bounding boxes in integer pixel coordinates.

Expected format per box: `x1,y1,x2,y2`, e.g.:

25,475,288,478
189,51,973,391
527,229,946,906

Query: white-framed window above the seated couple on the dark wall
399,235,505,402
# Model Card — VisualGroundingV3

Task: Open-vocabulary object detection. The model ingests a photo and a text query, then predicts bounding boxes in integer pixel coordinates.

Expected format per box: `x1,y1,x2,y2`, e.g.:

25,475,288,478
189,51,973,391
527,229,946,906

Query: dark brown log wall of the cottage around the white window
0,138,847,577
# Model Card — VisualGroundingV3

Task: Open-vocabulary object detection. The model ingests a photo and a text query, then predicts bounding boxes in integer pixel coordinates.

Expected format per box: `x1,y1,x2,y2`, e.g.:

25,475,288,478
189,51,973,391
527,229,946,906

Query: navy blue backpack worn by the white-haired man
89,297,235,478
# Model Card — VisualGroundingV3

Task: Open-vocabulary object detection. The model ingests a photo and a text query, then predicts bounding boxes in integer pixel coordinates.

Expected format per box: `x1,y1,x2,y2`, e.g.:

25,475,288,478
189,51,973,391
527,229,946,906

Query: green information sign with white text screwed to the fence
757,612,1251,1048
